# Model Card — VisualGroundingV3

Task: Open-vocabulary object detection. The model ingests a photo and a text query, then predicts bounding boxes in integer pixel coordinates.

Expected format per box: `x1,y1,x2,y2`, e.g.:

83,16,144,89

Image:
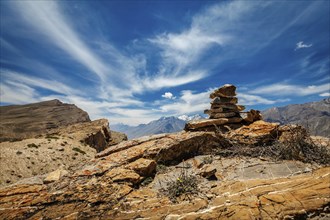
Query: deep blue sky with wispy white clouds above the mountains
0,0,330,126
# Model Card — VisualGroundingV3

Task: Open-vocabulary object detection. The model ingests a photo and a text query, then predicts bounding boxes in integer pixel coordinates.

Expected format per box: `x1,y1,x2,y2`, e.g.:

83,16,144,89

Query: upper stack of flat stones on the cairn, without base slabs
204,84,245,119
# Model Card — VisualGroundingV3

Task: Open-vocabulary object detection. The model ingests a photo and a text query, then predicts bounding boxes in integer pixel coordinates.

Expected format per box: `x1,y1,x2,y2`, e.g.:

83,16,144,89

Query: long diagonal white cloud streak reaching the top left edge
12,1,109,80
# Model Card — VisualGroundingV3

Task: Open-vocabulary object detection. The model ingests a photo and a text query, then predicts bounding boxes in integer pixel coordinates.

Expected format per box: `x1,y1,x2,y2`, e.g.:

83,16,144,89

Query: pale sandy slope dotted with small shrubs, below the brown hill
0,119,126,185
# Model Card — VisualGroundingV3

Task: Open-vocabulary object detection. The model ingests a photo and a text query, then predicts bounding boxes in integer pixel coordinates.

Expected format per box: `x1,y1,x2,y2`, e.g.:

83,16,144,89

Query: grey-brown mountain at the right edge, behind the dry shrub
262,98,330,137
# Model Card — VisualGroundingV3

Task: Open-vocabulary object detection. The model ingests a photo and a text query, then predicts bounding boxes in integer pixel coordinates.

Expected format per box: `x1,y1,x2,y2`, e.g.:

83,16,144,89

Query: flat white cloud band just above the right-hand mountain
250,83,330,96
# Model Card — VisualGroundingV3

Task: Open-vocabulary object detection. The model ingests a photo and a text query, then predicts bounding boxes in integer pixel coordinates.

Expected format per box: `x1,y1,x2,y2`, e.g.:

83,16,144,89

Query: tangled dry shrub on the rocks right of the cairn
214,125,330,165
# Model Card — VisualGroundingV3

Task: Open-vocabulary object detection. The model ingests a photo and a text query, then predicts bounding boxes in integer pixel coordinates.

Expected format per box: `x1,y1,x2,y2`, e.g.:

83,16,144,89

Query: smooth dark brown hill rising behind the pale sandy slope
0,99,90,142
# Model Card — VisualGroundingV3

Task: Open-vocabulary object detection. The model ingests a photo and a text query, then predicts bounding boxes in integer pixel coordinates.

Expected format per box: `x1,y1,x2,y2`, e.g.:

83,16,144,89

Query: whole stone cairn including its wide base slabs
185,84,262,132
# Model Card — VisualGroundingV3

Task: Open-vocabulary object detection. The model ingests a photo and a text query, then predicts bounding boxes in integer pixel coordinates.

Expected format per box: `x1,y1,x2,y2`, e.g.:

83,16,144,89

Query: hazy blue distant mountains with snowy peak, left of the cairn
110,115,204,139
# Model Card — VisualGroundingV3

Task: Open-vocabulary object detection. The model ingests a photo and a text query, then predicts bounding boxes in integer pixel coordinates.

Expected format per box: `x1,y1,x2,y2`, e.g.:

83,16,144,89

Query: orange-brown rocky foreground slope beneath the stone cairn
0,121,330,219
